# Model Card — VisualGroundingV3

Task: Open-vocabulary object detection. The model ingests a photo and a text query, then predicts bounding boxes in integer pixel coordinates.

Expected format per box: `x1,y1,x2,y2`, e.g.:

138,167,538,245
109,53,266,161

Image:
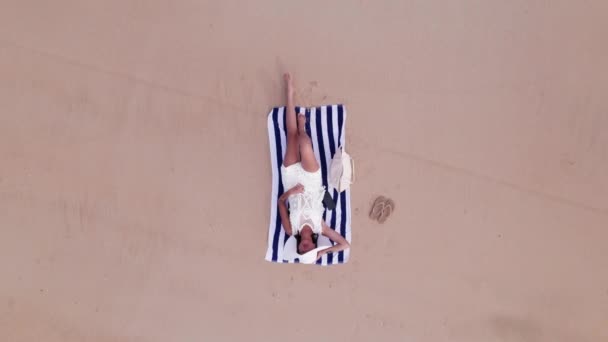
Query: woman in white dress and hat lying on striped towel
278,74,350,264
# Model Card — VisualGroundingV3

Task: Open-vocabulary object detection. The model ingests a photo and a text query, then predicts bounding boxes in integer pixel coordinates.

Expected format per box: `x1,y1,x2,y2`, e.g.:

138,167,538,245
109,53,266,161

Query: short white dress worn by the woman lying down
281,162,325,235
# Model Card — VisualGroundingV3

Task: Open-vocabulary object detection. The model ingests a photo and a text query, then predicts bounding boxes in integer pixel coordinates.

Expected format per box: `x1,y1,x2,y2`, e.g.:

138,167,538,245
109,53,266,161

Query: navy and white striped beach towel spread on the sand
266,105,351,265
